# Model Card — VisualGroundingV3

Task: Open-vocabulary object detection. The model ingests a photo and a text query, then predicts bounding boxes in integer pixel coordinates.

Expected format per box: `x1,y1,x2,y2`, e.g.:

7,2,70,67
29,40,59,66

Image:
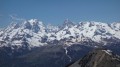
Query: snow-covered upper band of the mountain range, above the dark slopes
0,19,120,47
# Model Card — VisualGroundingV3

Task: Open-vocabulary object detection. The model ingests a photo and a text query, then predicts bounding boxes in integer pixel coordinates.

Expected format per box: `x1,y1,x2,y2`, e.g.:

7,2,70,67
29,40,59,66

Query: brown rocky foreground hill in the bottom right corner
68,49,120,67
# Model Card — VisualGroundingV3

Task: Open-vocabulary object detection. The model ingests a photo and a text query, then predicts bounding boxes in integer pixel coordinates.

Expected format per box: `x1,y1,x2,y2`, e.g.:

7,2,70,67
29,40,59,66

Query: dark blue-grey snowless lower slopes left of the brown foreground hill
0,45,92,67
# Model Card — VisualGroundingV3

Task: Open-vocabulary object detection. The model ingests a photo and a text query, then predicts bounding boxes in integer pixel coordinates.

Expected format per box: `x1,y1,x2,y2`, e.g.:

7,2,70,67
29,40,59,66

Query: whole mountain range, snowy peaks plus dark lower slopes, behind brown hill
0,19,120,67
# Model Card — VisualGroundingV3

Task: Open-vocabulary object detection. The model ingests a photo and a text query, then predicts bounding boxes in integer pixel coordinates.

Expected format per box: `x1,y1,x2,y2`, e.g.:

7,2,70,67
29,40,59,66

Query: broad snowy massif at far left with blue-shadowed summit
0,19,46,46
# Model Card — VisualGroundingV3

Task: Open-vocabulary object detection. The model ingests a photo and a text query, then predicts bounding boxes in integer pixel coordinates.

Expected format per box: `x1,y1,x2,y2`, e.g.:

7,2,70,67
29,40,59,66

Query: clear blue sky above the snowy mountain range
0,0,120,27
